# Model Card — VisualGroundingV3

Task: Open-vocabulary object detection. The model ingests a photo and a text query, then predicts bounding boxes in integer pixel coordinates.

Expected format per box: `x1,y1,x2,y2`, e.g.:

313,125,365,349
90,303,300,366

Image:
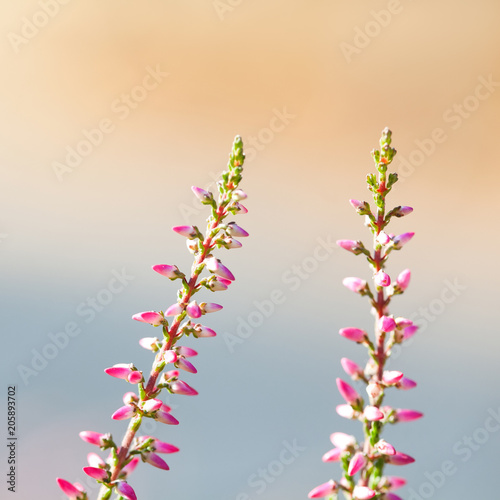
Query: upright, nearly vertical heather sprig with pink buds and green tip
309,129,423,500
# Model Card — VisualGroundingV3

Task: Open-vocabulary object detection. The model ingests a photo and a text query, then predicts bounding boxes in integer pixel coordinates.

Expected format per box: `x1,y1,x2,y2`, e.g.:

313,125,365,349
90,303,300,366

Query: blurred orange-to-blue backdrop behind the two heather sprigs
0,0,500,500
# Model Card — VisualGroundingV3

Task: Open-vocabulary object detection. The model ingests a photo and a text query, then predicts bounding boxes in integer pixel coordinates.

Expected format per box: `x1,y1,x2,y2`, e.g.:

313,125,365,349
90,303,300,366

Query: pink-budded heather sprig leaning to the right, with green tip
57,137,248,500
